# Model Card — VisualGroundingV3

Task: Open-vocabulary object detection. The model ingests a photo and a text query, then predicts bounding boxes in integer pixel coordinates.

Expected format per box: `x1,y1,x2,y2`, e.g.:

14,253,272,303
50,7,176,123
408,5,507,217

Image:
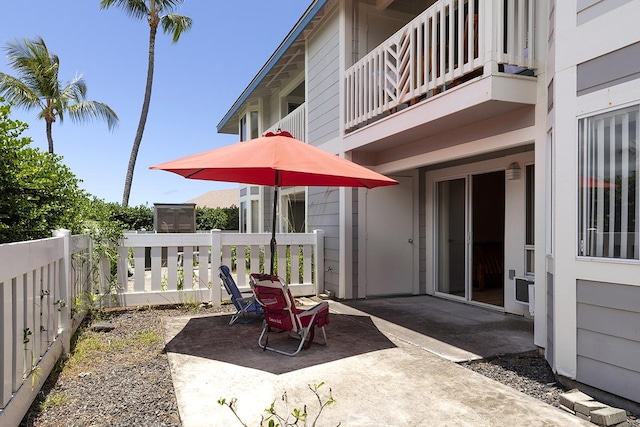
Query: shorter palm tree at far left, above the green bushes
0,37,118,154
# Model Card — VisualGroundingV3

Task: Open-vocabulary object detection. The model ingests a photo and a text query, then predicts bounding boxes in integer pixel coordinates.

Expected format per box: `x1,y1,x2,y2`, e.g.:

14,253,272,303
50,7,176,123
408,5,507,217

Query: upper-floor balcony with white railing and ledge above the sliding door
344,0,538,145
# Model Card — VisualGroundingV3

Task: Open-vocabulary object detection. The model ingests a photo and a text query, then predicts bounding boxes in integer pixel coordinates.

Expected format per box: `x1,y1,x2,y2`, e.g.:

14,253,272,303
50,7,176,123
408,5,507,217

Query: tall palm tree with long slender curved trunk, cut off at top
100,0,192,206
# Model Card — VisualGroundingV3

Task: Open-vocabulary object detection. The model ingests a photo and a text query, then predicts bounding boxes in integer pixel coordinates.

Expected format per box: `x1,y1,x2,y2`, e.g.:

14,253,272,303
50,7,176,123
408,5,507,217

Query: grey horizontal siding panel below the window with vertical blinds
576,280,640,402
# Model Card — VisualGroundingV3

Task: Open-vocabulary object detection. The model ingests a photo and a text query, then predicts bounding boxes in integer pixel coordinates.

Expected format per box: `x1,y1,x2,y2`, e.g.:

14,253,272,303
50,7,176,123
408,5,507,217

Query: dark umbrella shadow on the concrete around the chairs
165,313,396,375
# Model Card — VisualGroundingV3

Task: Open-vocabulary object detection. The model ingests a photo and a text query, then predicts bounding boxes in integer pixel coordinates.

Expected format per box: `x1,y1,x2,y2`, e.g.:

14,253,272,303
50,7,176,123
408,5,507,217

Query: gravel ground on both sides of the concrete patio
20,306,640,427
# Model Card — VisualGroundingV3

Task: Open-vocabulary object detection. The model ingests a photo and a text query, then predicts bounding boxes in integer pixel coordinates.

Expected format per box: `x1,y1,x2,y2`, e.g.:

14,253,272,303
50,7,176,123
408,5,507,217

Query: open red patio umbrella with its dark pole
149,132,398,274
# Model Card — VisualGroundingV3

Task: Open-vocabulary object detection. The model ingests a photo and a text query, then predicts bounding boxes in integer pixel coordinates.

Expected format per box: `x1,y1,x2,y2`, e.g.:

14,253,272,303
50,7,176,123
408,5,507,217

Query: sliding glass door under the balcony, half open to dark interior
435,170,505,307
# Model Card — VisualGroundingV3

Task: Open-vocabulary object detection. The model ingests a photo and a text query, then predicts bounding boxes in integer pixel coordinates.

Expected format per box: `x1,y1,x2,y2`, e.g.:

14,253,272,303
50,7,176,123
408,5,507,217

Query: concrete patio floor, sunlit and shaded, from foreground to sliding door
164,296,593,427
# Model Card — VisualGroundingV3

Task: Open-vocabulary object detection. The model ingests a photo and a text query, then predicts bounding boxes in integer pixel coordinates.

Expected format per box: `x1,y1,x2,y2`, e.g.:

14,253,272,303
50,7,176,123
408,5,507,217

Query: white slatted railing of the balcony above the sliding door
345,0,536,131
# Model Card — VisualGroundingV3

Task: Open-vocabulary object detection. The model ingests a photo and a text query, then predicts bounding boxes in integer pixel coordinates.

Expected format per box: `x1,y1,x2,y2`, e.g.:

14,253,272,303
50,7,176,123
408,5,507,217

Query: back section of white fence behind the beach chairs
112,230,324,307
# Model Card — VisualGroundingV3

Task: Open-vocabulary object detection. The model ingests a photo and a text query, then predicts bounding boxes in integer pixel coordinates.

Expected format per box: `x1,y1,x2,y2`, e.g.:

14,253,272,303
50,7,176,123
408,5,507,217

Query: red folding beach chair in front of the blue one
250,273,329,356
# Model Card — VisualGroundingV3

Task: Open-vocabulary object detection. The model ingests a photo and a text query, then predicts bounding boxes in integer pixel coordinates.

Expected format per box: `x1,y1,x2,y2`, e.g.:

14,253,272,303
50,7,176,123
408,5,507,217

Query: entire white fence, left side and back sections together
0,230,324,426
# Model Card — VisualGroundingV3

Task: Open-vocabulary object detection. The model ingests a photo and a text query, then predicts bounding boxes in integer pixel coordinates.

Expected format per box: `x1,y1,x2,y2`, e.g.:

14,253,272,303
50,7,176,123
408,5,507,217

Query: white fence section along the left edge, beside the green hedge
0,230,92,426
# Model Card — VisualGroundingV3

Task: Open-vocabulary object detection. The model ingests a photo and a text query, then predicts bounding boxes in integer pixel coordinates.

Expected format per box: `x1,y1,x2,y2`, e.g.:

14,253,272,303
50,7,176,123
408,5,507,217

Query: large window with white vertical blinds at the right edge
578,106,640,260
